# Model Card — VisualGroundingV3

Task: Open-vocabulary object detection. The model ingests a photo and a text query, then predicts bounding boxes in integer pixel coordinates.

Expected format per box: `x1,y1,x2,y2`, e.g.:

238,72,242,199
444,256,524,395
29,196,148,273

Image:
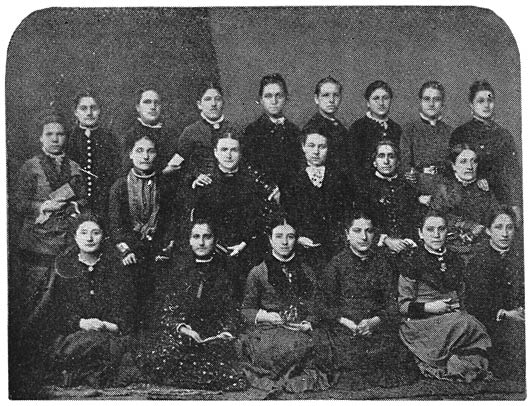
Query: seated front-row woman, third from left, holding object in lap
242,219,329,392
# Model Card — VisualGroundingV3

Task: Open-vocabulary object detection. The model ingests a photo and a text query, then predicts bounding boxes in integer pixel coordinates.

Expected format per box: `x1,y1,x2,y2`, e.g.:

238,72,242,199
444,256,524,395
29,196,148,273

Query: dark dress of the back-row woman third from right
346,115,402,178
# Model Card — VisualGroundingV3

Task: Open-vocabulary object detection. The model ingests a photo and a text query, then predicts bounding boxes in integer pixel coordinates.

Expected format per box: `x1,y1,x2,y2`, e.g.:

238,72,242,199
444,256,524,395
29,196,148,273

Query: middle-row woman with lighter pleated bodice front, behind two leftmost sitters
109,134,183,328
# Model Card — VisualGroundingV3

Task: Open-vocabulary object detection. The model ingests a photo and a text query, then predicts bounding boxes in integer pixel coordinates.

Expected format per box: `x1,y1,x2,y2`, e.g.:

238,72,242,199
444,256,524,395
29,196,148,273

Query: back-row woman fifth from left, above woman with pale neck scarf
303,76,348,170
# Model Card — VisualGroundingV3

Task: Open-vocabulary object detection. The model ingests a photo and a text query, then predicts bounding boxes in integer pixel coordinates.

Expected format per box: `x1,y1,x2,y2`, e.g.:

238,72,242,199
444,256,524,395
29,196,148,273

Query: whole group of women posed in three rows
13,74,524,392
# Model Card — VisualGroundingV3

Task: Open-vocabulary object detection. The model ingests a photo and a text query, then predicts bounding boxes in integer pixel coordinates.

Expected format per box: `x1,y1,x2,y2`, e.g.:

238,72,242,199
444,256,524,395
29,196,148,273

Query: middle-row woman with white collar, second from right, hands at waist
360,140,422,253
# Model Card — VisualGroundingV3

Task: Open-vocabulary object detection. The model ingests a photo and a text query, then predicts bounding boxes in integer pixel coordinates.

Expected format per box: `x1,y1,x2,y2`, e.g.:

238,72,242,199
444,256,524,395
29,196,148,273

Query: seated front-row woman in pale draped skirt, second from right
398,211,491,382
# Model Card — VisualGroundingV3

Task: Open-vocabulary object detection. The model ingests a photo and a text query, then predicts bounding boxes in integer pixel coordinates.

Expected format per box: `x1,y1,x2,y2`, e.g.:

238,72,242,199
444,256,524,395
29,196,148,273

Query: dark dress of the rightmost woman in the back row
449,118,522,206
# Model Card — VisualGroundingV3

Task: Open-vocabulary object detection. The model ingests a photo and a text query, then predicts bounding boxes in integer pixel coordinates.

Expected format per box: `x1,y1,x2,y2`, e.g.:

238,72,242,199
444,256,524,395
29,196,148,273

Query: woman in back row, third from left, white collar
177,83,231,186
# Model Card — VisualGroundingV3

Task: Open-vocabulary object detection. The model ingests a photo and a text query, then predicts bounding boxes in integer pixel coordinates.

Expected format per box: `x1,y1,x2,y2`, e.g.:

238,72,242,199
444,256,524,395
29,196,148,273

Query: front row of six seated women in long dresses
19,203,524,392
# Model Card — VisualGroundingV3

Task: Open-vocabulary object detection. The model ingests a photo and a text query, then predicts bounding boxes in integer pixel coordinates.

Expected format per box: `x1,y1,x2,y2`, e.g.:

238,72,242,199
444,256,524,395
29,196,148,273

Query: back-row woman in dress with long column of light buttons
67,91,120,216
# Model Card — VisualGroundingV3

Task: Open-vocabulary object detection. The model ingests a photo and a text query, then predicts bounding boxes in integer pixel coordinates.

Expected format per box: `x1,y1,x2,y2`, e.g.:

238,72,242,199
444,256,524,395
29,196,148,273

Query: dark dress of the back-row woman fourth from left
242,114,302,191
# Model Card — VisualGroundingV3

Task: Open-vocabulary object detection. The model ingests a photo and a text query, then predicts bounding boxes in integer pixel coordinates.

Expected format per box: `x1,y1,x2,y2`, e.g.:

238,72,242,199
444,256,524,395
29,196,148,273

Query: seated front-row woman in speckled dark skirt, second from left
138,219,248,391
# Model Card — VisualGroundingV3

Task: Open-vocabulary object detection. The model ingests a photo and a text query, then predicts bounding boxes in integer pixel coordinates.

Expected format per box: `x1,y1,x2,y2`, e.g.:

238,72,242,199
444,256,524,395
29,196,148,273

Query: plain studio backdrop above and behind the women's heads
6,7,521,235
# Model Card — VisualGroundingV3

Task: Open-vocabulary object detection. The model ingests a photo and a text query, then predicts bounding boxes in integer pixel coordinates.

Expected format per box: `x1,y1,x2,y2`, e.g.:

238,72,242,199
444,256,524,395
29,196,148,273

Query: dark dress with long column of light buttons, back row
67,125,120,219
